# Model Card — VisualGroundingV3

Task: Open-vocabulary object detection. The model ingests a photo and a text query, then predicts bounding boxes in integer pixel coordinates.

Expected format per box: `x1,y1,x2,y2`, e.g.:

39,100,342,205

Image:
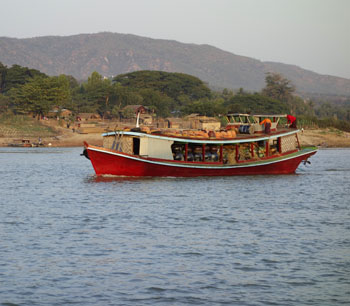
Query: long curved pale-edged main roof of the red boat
102,129,300,144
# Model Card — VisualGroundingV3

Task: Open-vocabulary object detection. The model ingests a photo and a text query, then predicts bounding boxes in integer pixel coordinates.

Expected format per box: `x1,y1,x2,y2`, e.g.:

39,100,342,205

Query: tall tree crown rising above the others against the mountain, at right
262,72,295,102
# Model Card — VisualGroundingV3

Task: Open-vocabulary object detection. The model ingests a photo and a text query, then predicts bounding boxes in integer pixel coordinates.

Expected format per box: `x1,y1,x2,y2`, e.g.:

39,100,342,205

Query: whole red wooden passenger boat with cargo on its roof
82,114,317,177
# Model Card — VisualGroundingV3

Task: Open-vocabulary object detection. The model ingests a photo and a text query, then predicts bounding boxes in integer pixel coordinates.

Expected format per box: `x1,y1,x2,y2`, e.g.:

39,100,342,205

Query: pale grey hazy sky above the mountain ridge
0,0,350,79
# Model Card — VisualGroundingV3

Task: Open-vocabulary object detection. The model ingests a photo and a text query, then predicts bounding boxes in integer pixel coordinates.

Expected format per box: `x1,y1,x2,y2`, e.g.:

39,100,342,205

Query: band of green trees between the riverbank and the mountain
0,63,350,130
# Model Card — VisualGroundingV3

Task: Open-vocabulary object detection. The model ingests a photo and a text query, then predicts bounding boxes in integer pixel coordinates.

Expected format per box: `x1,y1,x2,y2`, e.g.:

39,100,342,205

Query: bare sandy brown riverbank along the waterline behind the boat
0,129,350,148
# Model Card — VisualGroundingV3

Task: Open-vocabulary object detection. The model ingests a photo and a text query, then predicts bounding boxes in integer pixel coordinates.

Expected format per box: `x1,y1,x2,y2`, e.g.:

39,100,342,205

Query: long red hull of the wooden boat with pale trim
86,145,316,177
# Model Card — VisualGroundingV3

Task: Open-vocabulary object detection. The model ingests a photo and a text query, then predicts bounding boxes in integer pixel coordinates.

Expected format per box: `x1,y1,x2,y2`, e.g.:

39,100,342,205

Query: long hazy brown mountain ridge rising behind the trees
0,32,350,97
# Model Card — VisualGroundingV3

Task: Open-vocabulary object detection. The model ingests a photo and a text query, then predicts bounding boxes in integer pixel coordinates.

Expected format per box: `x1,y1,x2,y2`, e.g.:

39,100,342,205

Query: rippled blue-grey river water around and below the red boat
0,148,350,306
